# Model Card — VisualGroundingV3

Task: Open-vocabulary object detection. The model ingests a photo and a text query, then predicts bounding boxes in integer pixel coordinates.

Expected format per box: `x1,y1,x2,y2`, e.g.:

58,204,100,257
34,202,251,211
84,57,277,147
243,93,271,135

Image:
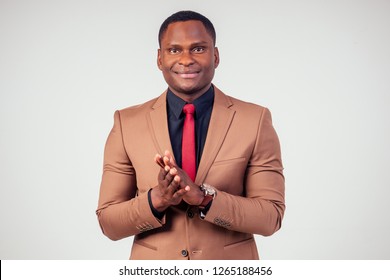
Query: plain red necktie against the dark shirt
181,104,196,181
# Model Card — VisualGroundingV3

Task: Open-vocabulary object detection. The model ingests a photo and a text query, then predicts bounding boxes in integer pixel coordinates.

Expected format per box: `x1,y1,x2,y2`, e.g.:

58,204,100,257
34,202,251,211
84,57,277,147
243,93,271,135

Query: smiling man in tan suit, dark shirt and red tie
97,11,285,259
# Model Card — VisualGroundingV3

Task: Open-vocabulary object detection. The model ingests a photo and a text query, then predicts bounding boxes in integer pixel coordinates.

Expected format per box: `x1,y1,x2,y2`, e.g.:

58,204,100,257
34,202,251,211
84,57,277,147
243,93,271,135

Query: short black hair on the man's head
158,11,217,47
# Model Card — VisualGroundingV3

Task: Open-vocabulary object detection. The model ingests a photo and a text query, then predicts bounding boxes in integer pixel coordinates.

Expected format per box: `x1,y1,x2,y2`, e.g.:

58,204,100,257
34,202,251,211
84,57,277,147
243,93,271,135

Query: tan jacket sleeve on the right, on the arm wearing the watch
205,108,285,236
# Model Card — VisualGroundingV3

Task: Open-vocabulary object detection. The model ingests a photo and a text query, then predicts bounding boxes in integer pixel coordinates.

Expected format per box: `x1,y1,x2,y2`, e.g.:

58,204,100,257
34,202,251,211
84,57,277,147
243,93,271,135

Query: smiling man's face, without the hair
157,20,219,101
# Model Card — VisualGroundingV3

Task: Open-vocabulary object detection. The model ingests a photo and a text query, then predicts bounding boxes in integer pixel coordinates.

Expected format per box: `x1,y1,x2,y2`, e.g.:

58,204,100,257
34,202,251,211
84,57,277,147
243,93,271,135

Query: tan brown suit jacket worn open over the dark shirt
96,87,285,259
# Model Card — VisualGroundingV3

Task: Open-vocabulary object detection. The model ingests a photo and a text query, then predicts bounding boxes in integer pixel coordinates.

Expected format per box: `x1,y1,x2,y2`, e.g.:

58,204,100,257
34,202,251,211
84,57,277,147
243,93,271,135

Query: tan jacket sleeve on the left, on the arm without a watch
96,111,165,240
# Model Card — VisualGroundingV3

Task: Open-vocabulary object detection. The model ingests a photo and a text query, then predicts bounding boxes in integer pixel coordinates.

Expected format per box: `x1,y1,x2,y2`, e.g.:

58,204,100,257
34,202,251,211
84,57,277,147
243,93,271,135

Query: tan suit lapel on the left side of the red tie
148,91,173,158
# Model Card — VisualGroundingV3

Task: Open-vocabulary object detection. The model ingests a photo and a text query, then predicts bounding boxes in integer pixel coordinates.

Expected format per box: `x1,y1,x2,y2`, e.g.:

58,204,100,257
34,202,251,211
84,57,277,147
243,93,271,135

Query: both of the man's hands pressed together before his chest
151,151,204,212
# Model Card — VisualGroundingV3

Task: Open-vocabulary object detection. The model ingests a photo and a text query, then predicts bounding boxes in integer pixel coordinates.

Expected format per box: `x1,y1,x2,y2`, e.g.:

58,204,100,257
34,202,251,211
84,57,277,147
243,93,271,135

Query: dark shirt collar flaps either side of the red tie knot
167,85,214,119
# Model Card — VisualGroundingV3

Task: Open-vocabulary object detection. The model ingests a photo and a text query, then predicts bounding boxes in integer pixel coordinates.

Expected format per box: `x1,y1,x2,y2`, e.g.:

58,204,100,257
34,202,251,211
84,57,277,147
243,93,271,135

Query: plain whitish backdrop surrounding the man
0,0,390,259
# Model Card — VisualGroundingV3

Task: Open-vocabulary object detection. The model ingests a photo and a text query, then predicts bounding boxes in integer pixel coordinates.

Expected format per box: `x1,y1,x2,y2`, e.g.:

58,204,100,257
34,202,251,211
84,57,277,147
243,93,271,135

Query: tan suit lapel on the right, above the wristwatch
195,86,235,184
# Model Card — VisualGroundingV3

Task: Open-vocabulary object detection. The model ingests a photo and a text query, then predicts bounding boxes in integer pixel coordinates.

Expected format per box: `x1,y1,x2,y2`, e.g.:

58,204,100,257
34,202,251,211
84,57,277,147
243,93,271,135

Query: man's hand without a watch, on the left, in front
150,162,189,212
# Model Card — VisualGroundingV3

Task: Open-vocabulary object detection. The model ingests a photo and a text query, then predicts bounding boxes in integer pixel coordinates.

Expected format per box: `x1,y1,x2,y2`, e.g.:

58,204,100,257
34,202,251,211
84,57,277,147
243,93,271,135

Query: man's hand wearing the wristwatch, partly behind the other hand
155,151,204,205
